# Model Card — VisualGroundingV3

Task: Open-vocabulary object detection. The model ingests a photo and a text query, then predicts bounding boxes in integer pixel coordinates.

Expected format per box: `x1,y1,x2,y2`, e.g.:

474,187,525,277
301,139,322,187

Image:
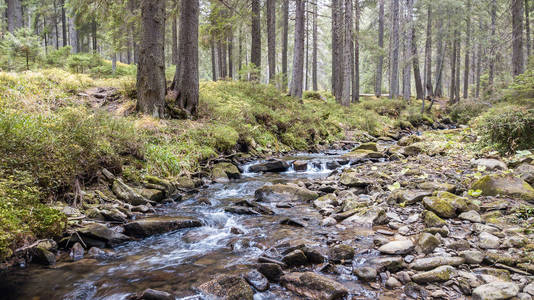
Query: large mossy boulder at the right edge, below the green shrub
471,174,534,202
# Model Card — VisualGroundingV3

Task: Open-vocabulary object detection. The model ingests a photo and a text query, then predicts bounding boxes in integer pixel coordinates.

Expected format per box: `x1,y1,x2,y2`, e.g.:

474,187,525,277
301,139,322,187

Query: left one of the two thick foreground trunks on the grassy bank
137,0,165,118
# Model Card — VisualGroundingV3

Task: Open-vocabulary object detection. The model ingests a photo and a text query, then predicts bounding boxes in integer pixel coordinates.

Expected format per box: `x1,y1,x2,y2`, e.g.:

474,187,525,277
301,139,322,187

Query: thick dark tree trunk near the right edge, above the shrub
512,0,525,76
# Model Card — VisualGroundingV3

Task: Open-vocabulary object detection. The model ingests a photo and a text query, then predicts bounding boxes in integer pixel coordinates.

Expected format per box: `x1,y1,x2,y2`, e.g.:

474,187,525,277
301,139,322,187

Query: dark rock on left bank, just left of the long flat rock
74,223,131,248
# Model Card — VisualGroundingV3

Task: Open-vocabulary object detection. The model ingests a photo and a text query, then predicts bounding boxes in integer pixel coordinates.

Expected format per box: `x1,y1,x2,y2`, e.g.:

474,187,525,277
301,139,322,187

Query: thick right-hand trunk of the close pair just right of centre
341,0,354,106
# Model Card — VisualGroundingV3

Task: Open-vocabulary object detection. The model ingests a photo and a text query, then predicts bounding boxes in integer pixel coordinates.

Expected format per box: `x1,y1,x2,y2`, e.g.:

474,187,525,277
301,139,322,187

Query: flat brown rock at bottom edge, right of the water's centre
280,272,348,300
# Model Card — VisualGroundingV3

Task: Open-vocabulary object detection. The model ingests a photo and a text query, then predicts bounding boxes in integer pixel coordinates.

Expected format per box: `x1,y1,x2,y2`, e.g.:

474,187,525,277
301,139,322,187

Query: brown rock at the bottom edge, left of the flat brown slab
198,274,254,300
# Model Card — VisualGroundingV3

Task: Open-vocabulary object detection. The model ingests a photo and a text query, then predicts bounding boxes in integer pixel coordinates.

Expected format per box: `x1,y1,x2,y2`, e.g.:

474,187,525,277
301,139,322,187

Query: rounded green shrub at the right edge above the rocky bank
477,106,534,153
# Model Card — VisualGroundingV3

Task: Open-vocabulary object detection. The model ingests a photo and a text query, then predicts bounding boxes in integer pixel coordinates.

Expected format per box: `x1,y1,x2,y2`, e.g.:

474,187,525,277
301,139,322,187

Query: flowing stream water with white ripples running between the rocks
0,153,394,300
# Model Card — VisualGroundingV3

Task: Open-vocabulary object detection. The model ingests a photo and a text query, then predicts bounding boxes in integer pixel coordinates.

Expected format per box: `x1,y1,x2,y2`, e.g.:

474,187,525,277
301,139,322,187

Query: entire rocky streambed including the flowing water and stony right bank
0,131,534,299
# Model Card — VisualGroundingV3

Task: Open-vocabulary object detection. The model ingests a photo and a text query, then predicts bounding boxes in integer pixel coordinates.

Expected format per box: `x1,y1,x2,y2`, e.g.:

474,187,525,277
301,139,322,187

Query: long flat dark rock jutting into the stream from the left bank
124,217,202,238
